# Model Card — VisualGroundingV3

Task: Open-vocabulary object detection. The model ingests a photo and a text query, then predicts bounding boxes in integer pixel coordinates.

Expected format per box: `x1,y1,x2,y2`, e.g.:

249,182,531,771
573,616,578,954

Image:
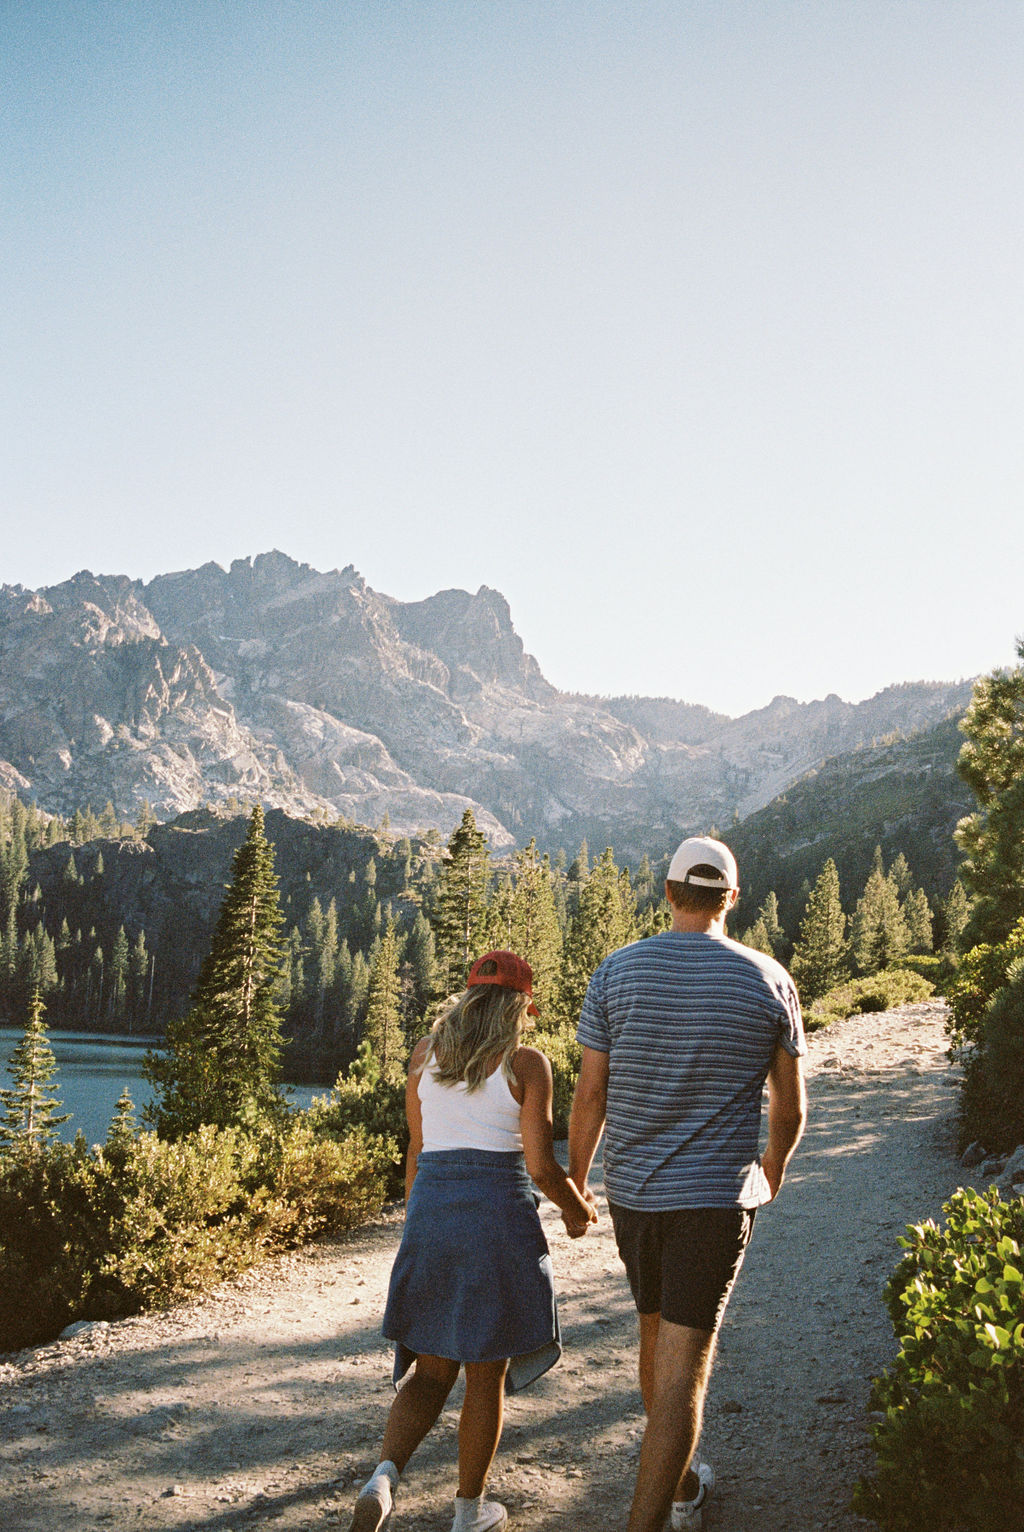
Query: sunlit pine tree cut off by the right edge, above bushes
955,637,1024,950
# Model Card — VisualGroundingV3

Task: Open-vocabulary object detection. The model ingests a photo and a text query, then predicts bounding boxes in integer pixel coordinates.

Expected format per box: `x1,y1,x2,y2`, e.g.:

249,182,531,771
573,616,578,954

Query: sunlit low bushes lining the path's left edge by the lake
0,1112,392,1351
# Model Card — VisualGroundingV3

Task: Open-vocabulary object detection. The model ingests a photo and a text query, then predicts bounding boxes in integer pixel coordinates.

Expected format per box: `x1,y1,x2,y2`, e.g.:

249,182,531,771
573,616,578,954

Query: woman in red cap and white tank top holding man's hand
351,951,596,1532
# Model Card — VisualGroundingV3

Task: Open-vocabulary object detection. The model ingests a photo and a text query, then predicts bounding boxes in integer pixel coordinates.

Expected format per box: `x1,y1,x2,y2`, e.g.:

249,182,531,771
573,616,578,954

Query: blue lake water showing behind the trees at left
0,1026,321,1144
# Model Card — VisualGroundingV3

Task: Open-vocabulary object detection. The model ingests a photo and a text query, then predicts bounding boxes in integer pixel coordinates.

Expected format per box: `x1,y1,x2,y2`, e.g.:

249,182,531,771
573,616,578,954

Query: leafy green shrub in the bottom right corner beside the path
854,1189,1024,1532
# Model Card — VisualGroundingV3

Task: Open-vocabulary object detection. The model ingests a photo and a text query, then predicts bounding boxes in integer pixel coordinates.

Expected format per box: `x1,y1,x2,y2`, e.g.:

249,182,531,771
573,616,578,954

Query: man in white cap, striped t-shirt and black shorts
569,836,806,1532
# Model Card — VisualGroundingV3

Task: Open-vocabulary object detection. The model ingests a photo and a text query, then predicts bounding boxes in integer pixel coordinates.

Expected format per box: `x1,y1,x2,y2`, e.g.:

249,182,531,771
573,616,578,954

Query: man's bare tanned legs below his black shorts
629,1314,714,1532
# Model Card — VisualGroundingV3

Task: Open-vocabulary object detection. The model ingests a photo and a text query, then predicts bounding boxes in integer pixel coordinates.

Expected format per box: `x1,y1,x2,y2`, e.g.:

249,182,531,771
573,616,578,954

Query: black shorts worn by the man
609,1203,754,1330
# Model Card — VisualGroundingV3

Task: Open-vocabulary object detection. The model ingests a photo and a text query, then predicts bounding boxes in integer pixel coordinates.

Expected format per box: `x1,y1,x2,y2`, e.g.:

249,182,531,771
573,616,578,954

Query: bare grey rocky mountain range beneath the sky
0,552,970,856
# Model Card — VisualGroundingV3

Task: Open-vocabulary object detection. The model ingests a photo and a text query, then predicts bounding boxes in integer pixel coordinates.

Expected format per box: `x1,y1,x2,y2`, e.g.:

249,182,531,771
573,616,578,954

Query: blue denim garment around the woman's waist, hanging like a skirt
382,1149,561,1394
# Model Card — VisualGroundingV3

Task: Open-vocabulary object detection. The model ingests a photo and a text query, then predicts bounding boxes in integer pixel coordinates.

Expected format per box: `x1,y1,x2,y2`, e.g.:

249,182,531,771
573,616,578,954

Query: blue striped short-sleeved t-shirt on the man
576,931,806,1210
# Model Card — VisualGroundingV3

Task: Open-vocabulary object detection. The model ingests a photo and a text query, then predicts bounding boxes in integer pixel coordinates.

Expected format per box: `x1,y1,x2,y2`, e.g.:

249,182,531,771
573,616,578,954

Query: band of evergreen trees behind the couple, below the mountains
0,766,966,1083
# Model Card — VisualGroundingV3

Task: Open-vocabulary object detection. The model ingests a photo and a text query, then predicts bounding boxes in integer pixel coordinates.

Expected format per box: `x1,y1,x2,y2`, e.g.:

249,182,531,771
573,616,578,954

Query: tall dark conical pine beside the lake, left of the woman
146,804,284,1138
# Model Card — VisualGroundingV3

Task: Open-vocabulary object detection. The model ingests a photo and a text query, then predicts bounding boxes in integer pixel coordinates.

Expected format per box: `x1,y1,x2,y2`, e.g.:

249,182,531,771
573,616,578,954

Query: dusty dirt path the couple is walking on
0,1003,964,1532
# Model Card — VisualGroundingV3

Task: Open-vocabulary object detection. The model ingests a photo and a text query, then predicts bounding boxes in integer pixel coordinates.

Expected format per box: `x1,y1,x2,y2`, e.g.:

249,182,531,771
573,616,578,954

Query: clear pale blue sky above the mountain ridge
0,0,1024,712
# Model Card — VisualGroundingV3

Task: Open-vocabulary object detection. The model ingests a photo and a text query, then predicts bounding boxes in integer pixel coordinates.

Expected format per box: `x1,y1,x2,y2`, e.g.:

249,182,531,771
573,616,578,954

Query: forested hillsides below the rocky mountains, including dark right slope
0,735,967,1082
